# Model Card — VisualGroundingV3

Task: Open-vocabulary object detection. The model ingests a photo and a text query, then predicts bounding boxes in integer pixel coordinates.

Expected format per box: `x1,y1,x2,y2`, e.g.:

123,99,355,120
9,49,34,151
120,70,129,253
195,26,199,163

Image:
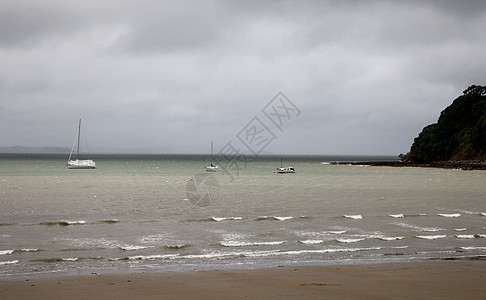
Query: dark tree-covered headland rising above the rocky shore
407,85,486,163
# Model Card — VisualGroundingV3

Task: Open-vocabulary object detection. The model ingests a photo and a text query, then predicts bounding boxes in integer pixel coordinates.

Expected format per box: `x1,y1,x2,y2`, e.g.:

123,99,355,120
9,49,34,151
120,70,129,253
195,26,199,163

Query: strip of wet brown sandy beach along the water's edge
0,261,486,299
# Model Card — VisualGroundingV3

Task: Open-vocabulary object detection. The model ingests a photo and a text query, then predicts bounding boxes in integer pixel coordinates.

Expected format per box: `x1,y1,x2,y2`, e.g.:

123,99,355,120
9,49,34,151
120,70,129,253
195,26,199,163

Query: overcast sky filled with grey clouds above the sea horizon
0,0,486,155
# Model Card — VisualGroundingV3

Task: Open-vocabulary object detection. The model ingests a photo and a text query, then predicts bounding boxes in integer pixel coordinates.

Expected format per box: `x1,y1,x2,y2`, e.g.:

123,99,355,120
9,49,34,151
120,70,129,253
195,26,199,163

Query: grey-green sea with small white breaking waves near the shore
0,155,486,278
